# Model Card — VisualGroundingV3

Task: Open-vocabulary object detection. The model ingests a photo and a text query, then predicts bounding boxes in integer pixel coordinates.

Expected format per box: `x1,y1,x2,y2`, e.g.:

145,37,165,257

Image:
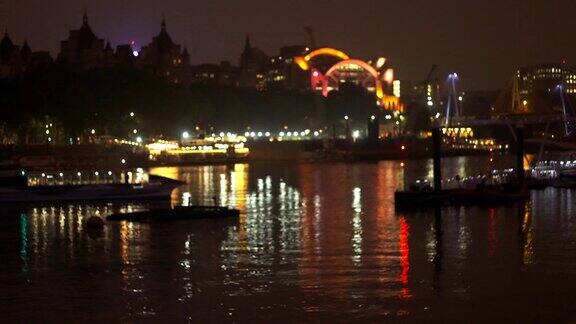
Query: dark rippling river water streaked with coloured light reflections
0,158,576,323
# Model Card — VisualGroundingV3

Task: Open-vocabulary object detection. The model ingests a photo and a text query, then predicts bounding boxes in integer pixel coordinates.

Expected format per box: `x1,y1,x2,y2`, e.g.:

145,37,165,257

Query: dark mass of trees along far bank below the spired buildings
0,63,394,144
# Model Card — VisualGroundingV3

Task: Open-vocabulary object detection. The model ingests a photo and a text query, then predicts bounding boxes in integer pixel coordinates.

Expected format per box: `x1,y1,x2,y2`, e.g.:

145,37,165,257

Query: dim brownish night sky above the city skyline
0,0,576,89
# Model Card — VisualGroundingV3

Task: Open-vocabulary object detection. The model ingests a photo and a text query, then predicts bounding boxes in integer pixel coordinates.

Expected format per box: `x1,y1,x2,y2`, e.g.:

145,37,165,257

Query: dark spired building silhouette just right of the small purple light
138,19,190,83
